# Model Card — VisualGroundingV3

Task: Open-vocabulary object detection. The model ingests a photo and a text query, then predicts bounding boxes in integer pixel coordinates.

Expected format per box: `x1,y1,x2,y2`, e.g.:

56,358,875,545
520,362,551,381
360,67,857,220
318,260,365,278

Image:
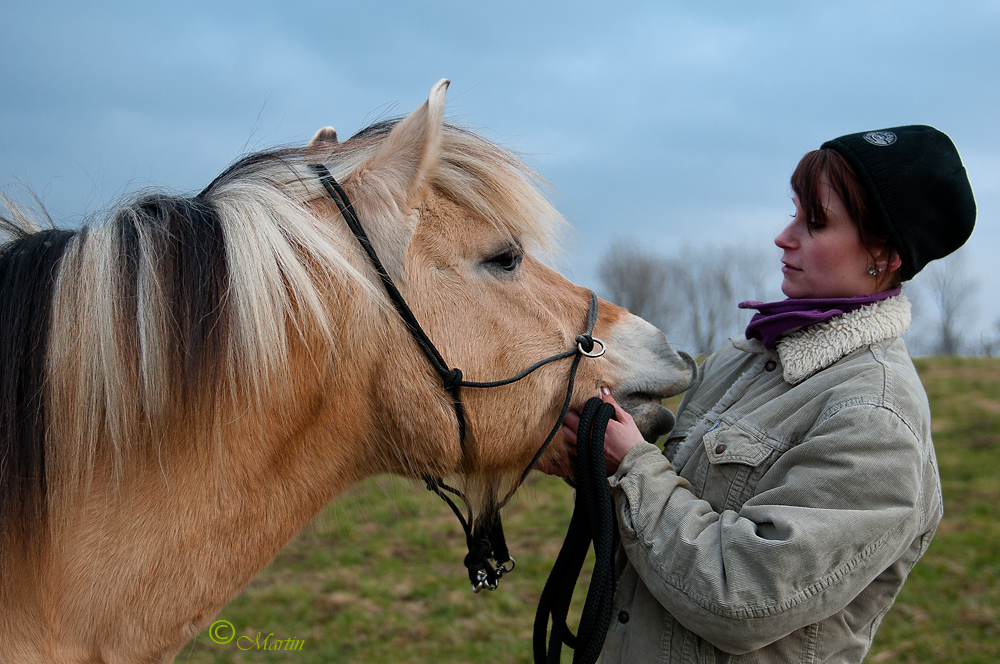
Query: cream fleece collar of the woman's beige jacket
733,295,910,385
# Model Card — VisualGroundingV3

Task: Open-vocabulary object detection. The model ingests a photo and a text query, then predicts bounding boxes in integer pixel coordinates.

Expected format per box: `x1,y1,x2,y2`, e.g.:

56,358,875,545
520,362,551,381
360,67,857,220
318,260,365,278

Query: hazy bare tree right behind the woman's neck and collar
914,251,980,355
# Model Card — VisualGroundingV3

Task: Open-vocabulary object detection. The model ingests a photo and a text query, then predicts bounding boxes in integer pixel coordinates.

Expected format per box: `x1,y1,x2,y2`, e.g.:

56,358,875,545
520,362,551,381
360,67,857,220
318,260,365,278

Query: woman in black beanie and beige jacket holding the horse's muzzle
564,126,975,662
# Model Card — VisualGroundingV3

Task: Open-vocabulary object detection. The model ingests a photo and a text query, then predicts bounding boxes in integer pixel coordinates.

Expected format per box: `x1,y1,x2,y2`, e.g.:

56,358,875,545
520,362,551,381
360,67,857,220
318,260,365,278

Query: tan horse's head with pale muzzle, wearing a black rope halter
311,81,691,508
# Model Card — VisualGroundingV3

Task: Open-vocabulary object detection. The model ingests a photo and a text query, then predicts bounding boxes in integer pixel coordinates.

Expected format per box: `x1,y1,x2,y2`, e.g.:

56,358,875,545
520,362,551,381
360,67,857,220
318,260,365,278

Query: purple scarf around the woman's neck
739,288,901,350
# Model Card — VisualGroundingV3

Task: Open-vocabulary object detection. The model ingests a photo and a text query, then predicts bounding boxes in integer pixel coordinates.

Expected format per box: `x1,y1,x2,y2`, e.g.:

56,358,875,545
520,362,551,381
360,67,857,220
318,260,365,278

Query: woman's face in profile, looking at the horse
774,176,877,298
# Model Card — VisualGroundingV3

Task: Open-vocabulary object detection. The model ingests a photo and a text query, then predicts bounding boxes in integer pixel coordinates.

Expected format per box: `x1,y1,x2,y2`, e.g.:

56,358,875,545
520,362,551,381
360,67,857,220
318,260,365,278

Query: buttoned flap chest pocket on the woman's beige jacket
701,424,778,512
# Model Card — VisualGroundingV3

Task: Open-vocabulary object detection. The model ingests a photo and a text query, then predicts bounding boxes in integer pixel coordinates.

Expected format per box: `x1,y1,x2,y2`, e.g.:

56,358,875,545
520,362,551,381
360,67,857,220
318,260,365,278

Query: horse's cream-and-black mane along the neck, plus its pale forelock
0,120,562,551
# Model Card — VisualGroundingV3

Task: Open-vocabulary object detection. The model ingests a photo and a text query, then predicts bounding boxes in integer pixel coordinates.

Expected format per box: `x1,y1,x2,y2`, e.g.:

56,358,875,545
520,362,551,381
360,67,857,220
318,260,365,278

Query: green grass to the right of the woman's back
868,358,1000,664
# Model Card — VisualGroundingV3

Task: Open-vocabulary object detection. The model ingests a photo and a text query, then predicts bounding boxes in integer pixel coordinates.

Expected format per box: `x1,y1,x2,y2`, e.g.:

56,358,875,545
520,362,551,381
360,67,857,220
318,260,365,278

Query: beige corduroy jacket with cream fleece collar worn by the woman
600,296,942,664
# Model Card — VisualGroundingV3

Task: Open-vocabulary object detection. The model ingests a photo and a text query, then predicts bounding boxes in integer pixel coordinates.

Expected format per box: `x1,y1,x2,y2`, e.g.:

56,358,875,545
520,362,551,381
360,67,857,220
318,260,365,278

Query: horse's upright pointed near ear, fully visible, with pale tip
358,78,451,205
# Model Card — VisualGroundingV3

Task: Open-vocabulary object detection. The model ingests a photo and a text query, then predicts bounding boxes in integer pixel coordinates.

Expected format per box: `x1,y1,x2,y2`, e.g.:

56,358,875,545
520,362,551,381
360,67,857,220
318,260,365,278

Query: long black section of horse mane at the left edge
0,224,76,549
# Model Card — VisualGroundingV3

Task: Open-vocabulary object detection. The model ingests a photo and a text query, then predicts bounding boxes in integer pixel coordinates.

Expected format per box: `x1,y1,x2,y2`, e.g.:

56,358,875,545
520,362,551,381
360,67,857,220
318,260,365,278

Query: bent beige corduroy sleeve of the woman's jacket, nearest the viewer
609,405,926,654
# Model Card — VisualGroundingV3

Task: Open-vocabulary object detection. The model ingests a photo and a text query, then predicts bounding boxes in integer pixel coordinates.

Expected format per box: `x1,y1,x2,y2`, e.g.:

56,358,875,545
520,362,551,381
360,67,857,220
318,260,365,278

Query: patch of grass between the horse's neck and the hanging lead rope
177,473,582,663
